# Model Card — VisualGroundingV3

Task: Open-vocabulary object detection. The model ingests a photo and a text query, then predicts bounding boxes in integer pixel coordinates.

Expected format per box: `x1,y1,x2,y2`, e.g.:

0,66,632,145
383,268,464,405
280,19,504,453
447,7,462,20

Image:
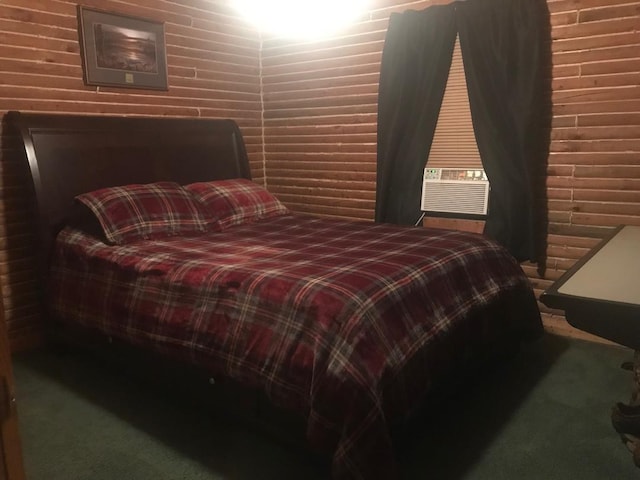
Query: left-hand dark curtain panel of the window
376,6,456,225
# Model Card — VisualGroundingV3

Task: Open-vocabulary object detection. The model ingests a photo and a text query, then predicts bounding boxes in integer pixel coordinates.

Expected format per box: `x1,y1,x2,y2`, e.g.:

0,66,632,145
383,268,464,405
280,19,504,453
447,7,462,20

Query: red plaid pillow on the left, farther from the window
76,182,207,245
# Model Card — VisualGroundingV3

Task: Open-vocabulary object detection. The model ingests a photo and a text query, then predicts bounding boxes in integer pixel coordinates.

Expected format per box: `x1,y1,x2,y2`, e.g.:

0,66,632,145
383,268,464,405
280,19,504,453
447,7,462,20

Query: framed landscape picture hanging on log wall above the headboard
78,5,169,90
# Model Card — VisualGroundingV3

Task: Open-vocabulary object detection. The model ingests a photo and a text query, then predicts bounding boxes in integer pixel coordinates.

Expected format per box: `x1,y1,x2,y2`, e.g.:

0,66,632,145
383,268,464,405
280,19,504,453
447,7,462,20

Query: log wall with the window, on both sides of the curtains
262,0,640,342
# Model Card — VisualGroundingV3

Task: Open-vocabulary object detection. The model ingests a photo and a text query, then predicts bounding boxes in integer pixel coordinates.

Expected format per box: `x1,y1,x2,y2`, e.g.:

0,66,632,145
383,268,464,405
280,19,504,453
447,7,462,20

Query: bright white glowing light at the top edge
234,0,368,38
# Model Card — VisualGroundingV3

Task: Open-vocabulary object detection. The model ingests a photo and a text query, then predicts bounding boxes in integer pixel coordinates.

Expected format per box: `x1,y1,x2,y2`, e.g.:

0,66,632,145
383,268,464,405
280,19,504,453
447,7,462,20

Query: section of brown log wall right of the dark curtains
531,0,640,338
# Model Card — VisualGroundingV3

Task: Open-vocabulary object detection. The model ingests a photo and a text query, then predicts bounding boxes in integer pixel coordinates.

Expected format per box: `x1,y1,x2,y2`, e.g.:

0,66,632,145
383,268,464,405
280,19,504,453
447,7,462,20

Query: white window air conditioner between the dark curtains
421,168,489,216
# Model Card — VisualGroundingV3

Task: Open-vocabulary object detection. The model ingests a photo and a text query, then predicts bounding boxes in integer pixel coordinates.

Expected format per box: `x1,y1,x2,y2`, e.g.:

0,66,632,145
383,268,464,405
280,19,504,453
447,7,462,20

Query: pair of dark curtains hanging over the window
376,0,547,261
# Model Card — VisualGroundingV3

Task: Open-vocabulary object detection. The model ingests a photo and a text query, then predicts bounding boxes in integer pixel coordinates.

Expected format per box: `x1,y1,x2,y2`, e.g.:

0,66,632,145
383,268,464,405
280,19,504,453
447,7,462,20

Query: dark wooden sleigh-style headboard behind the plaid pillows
6,111,251,280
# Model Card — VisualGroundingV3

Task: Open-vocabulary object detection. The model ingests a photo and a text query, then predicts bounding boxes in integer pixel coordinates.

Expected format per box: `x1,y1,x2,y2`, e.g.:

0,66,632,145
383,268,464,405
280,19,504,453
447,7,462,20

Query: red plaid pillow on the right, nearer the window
185,178,289,230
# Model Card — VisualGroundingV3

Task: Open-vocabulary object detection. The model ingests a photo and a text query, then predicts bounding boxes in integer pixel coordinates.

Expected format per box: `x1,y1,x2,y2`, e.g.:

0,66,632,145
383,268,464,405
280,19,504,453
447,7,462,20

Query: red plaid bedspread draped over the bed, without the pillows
49,215,540,478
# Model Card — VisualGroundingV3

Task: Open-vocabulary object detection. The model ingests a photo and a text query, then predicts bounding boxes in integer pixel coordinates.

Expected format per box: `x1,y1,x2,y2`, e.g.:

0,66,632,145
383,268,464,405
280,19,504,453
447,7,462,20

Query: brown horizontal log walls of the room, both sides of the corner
0,0,640,349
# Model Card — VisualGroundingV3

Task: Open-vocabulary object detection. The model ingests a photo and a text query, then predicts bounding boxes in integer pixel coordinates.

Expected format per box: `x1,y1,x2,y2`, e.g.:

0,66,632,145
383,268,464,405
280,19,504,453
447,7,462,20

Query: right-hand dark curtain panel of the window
457,0,545,261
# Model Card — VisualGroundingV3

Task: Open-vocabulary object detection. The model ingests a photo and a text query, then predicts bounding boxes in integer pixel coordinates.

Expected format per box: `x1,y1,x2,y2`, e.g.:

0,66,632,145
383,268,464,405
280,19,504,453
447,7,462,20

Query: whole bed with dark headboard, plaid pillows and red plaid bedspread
8,112,542,478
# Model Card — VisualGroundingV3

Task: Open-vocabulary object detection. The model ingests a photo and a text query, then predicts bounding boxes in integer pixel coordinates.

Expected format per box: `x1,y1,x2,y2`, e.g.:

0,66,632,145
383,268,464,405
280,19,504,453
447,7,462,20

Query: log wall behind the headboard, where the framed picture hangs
0,0,264,350
